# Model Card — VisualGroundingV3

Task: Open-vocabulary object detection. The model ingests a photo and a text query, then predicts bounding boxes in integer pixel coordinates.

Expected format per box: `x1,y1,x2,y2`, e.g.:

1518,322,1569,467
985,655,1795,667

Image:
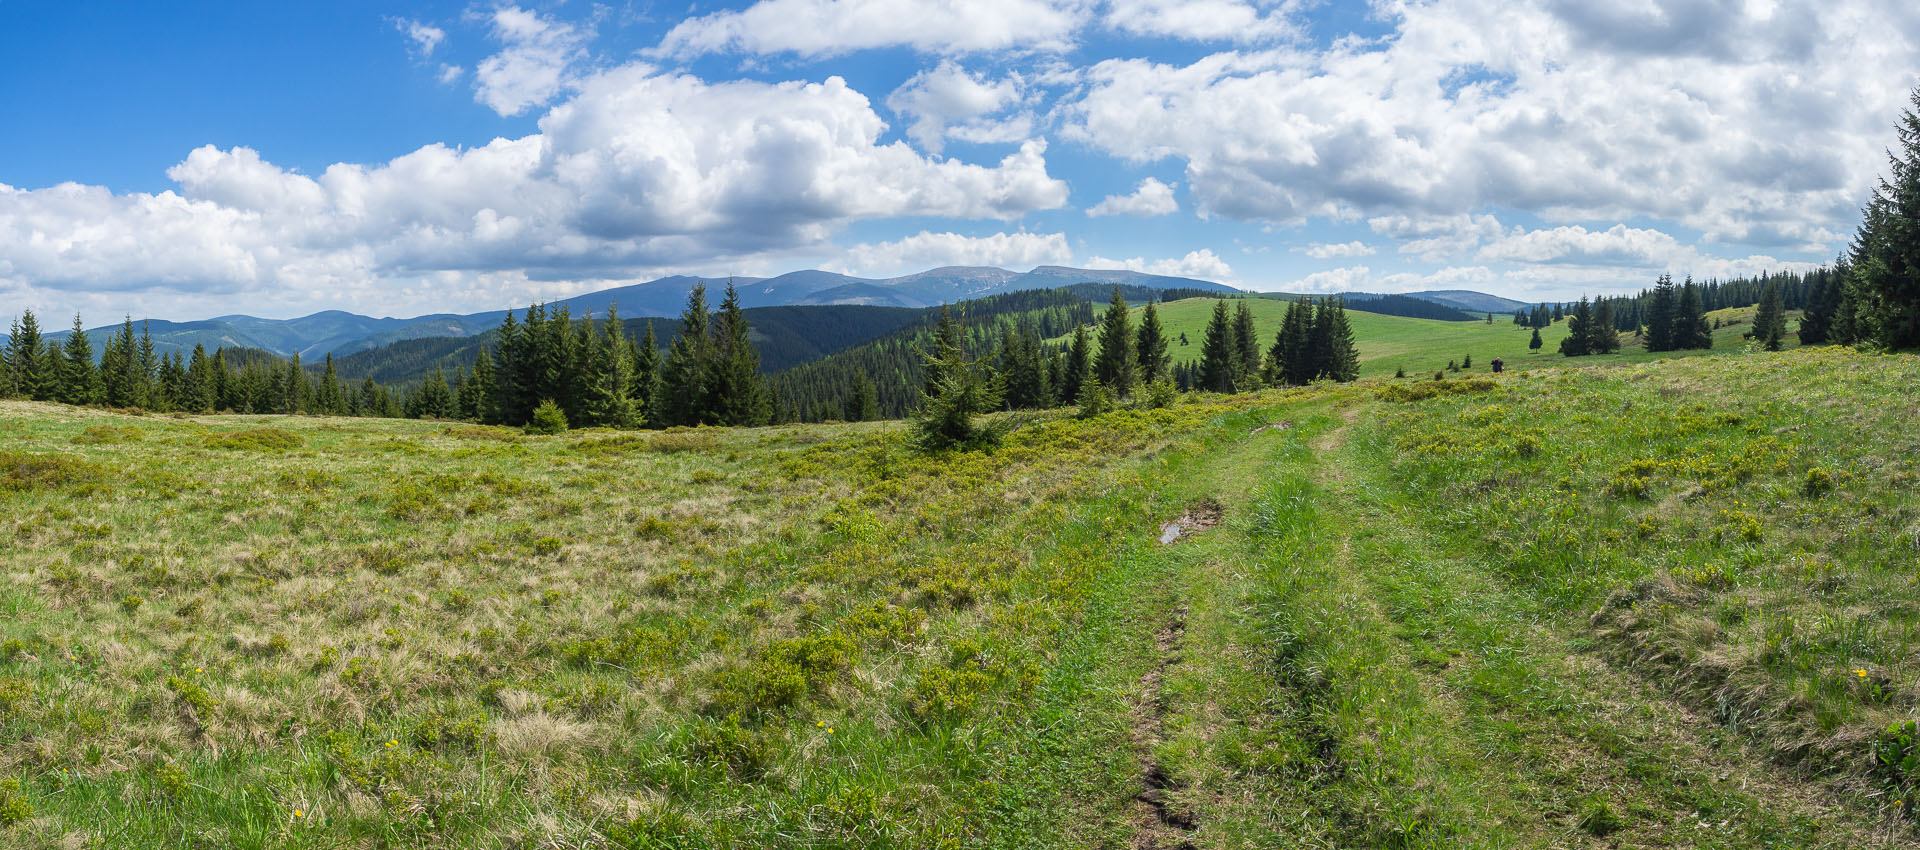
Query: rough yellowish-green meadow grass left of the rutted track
0,399,1274,846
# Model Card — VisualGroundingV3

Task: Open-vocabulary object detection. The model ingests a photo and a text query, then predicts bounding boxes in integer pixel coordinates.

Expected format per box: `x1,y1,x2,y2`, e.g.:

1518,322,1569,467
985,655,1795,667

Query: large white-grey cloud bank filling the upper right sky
1064,0,1920,249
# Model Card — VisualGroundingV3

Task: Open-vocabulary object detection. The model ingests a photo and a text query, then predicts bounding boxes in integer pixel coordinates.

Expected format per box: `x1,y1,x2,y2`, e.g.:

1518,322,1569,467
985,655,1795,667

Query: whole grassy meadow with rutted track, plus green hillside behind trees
0,343,1920,850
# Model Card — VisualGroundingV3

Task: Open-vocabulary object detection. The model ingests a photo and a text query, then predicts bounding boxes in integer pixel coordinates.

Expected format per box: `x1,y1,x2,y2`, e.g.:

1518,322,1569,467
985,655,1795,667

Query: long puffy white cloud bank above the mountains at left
0,65,1068,316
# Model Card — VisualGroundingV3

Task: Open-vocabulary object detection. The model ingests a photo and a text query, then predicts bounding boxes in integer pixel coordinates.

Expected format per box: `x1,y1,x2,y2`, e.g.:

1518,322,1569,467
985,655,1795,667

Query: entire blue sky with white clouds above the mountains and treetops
0,0,1920,320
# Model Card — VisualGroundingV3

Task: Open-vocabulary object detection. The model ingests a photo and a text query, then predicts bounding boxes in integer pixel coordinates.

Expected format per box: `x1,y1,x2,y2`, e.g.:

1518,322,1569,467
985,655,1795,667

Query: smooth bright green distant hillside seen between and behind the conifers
1050,297,1799,378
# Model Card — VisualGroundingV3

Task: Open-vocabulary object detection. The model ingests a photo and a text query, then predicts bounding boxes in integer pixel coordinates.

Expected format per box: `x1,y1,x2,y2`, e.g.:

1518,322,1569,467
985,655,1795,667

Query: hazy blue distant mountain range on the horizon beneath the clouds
48,265,1240,361
